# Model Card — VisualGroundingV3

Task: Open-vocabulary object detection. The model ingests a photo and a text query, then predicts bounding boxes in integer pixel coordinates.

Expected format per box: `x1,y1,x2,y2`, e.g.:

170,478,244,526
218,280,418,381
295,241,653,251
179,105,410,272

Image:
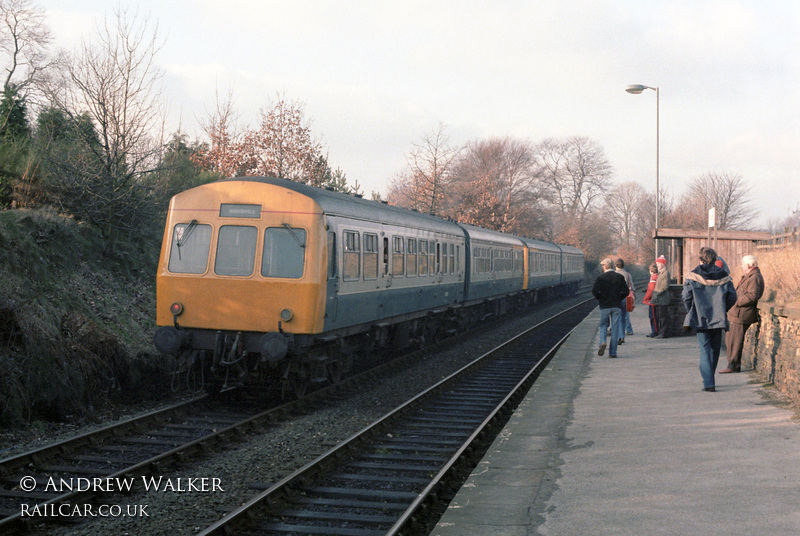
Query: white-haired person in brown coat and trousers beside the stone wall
719,255,764,374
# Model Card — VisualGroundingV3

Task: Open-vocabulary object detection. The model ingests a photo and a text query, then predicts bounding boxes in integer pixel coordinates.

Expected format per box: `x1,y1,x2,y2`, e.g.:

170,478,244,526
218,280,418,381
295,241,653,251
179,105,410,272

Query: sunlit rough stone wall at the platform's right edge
742,303,800,403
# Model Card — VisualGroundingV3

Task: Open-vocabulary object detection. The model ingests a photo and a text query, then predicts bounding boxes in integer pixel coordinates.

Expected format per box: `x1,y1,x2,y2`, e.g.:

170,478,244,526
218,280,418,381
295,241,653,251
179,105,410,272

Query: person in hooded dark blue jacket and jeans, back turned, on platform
681,247,736,392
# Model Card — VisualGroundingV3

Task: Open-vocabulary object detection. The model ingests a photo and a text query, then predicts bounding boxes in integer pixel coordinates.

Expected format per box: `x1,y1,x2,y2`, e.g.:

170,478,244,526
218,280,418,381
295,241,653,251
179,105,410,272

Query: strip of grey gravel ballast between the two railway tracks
15,298,579,536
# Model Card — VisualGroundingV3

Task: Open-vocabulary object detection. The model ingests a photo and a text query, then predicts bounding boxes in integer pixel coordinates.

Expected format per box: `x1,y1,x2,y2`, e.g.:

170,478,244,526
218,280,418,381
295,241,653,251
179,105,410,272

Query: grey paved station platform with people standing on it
431,303,800,536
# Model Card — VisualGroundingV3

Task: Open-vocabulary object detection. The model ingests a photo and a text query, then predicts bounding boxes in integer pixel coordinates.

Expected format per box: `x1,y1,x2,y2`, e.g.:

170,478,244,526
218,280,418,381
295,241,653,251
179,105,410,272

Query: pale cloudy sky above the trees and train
38,0,800,228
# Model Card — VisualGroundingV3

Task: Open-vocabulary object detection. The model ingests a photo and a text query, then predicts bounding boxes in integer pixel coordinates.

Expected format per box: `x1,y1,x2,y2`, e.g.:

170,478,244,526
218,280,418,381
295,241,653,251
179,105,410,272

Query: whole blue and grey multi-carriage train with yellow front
154,177,584,397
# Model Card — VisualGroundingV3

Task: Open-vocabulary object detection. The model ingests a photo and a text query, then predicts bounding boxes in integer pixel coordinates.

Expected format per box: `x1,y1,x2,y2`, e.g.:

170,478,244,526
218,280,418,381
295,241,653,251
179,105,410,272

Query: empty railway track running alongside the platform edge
201,300,595,536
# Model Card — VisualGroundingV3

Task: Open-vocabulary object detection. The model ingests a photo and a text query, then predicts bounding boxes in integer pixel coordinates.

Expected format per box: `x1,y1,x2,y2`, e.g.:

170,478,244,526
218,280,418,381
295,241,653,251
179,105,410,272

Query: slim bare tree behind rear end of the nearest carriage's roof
408,123,460,214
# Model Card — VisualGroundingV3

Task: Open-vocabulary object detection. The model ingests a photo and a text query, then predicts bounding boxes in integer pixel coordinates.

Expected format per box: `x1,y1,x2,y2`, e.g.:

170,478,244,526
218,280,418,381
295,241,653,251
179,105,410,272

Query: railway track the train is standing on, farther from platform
0,286,600,534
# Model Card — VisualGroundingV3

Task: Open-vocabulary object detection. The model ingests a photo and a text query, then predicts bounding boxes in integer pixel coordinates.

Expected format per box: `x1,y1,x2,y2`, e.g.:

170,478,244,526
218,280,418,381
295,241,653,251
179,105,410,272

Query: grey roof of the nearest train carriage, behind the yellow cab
219,177,463,235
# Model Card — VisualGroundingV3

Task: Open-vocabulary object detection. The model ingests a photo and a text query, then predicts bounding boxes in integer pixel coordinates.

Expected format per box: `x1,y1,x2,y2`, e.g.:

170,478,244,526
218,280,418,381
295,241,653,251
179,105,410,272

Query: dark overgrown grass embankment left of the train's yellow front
0,210,169,426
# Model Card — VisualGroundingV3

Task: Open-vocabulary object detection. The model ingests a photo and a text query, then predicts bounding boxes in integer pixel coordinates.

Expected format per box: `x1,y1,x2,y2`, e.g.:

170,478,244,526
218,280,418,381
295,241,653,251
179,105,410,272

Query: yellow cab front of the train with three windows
156,180,327,340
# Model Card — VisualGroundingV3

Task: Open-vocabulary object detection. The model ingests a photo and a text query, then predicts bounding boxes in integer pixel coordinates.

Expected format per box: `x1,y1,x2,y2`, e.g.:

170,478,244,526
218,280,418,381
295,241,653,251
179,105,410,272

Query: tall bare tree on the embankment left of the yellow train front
42,8,163,239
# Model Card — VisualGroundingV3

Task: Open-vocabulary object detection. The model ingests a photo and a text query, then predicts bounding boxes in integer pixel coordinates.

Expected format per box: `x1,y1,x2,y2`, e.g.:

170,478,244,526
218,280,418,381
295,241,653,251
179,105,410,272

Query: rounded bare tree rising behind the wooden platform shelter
681,173,758,229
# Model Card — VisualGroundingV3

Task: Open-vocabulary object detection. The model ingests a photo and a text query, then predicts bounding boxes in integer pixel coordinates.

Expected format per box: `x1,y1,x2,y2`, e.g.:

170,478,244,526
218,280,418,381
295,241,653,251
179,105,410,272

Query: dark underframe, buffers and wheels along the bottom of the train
164,284,577,398
